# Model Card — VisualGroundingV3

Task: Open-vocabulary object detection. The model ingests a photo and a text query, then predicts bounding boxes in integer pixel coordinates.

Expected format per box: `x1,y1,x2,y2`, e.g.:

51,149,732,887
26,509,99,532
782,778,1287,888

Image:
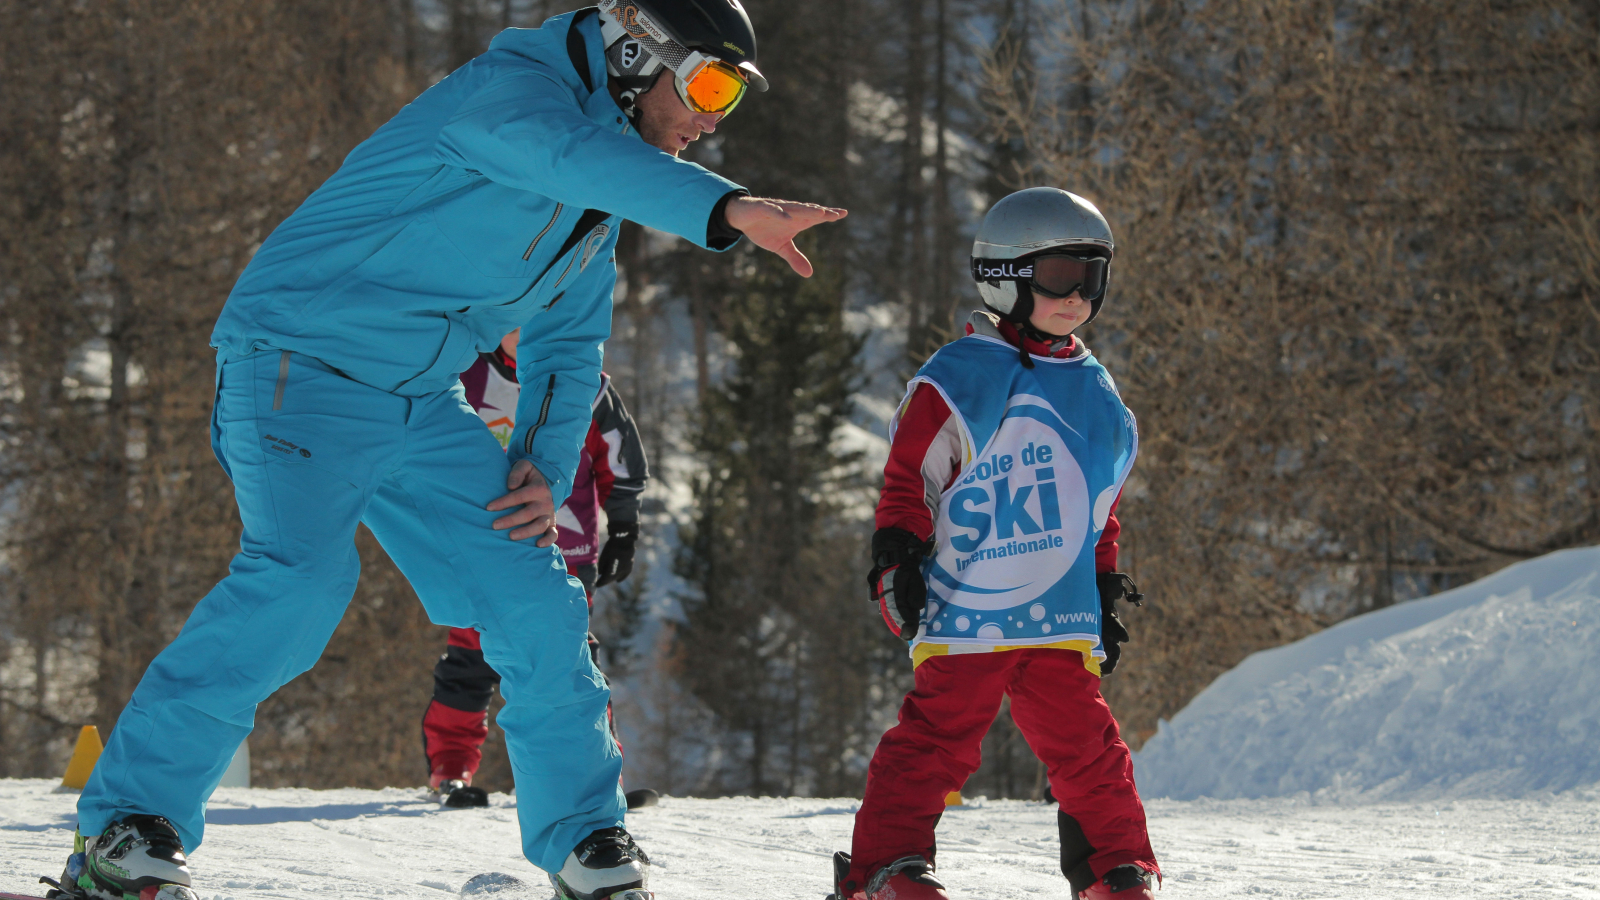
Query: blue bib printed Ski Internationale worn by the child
907,335,1139,671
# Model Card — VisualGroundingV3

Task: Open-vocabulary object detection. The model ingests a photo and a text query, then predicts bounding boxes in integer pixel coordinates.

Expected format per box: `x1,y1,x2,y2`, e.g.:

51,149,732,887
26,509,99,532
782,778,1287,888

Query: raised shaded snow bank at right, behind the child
1134,548,1600,794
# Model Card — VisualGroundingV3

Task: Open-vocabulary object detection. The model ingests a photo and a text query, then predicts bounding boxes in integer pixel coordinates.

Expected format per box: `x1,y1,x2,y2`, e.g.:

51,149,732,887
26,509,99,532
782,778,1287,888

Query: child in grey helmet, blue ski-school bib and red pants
834,187,1160,900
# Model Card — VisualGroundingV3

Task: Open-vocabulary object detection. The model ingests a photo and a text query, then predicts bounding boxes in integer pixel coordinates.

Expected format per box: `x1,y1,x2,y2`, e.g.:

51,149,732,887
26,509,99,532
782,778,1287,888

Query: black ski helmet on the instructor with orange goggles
600,0,766,103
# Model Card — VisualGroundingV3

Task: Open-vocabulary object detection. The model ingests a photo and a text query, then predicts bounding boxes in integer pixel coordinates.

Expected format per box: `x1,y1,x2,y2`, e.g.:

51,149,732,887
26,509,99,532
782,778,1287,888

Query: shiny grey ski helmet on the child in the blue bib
973,187,1117,325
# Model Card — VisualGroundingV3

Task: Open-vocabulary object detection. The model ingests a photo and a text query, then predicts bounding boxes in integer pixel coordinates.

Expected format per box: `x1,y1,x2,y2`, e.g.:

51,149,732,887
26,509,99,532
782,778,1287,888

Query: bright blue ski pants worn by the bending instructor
78,351,626,871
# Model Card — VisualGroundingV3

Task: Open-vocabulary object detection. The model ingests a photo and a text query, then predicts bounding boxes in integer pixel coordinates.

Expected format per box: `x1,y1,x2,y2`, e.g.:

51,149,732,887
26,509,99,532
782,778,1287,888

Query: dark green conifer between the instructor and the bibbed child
678,243,883,794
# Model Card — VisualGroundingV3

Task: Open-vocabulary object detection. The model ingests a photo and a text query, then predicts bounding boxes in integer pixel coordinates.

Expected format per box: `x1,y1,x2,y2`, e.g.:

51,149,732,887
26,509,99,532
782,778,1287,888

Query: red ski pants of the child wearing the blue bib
850,649,1158,884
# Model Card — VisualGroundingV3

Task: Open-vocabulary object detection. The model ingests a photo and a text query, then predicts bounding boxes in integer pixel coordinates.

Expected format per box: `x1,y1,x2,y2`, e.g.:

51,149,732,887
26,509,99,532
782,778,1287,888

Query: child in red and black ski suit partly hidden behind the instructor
422,328,656,809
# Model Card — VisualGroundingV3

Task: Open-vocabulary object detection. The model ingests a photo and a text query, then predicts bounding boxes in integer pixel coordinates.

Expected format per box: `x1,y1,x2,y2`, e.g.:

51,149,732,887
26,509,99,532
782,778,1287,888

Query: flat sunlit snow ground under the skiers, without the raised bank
0,780,1600,900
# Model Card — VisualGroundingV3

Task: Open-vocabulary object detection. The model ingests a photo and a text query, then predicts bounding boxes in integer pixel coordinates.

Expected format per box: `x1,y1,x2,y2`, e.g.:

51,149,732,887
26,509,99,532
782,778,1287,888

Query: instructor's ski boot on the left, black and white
51,815,200,900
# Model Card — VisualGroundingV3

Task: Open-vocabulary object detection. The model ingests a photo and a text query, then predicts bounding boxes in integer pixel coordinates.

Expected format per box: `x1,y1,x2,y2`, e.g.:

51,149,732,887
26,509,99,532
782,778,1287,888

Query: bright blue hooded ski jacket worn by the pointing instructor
211,10,741,506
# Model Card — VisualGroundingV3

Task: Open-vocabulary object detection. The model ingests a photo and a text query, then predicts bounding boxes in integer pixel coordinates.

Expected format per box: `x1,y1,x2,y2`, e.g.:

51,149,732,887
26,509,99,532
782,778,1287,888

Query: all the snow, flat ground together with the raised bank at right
12,548,1600,900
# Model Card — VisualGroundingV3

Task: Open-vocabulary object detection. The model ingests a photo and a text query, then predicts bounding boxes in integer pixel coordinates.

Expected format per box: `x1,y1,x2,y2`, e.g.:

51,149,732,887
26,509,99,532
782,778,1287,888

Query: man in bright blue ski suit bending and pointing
61,0,845,900
